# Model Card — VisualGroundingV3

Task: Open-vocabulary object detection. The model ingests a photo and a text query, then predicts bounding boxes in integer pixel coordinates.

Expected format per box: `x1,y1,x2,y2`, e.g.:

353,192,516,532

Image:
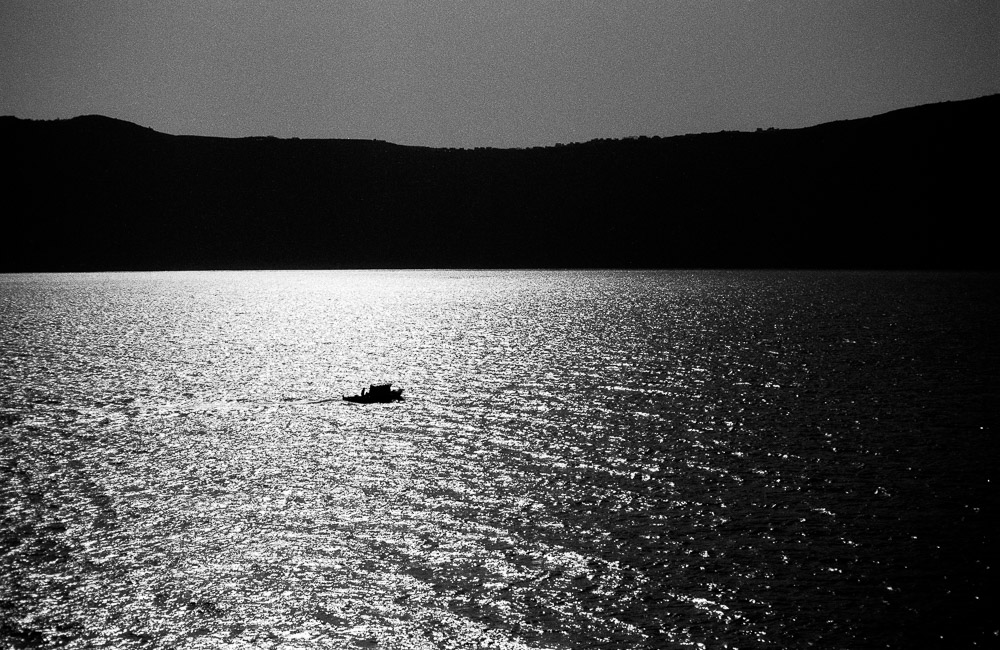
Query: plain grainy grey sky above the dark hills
0,0,1000,148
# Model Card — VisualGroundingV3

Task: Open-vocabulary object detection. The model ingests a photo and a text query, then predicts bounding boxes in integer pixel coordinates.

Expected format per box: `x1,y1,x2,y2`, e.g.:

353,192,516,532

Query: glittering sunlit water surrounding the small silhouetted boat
0,270,1000,650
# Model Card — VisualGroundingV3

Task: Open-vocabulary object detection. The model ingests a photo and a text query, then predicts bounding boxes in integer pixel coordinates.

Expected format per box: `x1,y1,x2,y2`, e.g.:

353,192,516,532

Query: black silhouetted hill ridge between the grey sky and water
0,96,1000,271
